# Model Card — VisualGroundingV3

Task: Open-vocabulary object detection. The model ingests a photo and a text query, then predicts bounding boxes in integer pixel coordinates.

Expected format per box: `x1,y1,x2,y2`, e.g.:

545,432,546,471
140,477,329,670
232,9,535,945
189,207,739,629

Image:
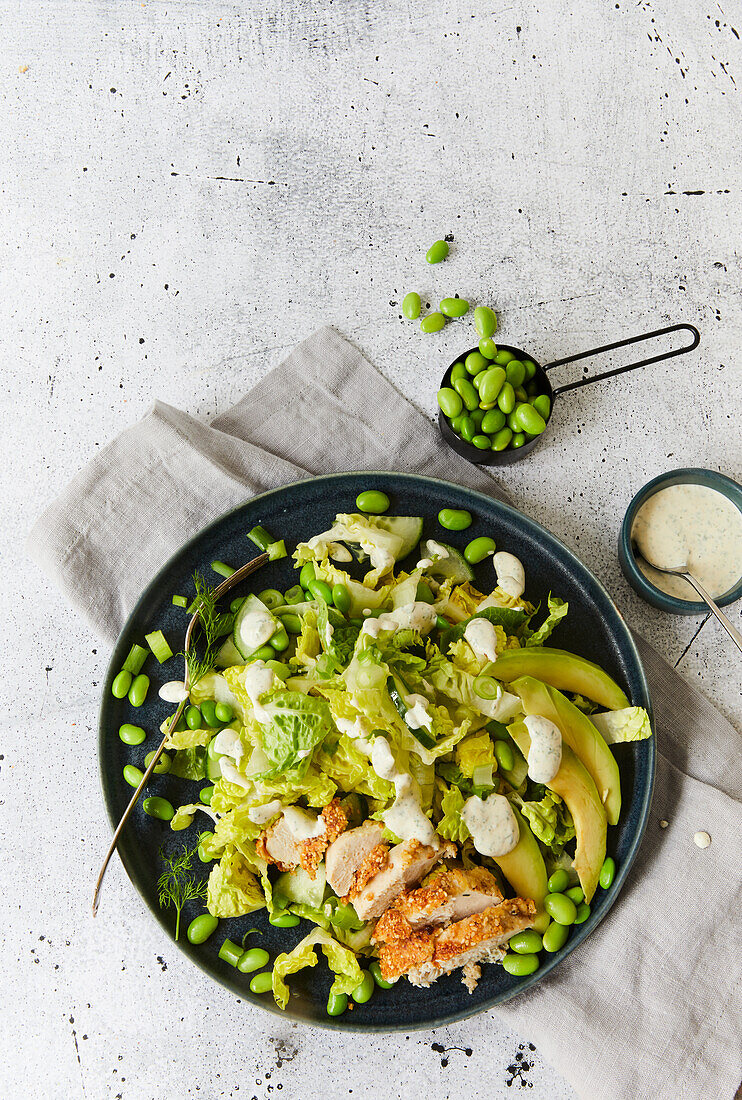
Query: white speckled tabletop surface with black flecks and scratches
0,0,742,1100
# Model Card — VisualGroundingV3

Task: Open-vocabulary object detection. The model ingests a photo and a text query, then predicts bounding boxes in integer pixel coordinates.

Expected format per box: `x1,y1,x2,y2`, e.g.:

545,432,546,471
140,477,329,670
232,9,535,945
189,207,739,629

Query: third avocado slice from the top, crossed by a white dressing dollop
508,722,608,902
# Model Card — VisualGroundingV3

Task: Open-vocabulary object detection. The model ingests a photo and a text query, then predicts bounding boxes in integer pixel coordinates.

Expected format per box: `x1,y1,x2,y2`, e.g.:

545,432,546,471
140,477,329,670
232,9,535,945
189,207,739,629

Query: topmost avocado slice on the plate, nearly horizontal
489,646,631,711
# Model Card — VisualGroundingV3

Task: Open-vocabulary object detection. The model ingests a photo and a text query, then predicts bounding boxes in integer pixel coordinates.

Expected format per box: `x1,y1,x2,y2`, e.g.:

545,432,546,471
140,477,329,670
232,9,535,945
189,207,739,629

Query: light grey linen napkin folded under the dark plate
27,329,742,1100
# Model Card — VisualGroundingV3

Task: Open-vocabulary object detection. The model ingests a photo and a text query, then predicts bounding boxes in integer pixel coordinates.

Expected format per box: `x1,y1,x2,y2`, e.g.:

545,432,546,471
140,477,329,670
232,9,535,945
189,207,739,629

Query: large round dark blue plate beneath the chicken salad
100,473,655,1031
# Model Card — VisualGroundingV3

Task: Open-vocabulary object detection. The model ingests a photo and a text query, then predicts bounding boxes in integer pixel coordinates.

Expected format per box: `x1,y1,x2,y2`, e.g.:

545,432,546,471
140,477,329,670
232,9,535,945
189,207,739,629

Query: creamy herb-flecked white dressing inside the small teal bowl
631,484,742,602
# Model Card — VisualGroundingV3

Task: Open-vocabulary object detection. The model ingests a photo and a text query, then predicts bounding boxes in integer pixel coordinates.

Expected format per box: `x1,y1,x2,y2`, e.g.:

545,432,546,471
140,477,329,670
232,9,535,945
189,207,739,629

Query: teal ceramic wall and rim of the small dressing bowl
618,469,742,615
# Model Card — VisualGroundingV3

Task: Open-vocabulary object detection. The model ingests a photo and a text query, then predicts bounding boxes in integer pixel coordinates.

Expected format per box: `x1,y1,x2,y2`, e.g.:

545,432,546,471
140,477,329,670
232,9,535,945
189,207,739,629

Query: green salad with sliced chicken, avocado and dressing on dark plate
122,492,651,1014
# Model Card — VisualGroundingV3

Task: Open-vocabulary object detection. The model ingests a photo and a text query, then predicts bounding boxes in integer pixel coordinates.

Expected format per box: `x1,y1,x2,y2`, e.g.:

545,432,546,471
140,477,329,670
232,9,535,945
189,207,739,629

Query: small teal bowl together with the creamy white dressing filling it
619,470,742,615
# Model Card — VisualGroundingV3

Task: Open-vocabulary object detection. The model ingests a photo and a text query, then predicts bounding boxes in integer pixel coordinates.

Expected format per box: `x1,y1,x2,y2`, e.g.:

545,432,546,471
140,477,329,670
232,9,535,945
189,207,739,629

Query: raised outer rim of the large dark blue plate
98,470,656,1034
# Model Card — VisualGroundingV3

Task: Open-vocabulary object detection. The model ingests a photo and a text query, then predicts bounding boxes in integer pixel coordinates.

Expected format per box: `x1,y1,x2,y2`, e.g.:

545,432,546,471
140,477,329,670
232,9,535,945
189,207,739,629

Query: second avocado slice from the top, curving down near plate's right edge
510,677,621,825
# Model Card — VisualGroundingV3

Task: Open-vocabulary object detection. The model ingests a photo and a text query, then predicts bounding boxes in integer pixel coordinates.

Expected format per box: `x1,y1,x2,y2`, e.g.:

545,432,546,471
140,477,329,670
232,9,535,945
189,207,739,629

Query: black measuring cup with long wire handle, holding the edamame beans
438,325,700,466
